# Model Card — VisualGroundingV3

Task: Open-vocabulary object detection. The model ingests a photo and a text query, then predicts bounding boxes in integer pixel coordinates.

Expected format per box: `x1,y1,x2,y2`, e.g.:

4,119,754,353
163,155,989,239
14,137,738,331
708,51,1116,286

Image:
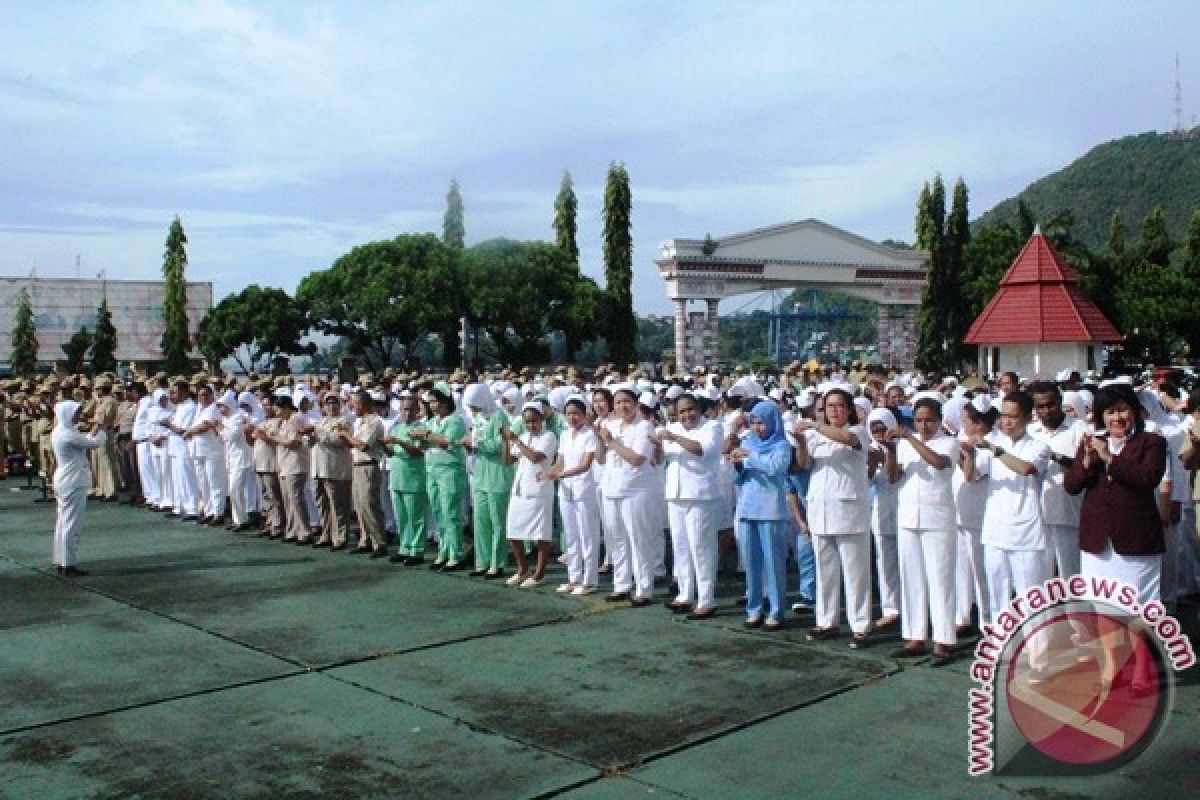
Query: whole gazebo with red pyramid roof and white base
965,227,1123,378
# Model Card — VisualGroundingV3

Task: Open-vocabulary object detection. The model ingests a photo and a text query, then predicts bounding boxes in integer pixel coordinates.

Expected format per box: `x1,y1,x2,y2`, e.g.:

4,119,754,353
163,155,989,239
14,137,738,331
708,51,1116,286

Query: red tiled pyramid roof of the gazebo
965,230,1123,344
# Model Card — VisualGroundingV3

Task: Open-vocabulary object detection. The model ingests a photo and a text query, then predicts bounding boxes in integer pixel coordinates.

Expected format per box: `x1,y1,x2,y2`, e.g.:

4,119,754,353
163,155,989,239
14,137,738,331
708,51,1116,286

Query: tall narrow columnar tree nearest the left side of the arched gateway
604,162,637,363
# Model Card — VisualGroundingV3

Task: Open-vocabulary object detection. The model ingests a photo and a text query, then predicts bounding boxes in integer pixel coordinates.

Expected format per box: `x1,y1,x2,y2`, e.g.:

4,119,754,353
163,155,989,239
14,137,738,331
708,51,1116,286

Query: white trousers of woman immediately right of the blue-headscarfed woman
812,530,871,633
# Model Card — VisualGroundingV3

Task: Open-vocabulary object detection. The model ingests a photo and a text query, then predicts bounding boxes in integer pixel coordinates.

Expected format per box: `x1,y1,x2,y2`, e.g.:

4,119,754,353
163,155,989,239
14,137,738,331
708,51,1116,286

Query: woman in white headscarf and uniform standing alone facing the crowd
50,401,107,576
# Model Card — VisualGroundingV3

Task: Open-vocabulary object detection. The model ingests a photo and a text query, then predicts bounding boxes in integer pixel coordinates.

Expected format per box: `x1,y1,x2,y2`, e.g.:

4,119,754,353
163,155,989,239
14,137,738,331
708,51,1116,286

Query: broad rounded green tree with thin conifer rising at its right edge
296,234,463,368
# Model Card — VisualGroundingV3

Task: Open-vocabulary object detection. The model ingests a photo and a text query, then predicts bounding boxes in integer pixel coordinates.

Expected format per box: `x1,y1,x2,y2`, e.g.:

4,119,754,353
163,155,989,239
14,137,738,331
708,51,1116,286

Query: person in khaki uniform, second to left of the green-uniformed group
312,392,354,551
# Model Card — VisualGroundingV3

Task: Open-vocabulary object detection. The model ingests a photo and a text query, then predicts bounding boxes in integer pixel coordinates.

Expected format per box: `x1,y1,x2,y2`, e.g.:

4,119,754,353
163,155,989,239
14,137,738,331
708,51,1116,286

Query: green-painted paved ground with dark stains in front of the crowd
0,481,1200,800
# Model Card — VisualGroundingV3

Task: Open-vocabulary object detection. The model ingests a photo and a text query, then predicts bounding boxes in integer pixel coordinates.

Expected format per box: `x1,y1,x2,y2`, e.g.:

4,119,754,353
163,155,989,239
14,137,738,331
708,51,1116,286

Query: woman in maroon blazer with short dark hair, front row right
1066,384,1166,691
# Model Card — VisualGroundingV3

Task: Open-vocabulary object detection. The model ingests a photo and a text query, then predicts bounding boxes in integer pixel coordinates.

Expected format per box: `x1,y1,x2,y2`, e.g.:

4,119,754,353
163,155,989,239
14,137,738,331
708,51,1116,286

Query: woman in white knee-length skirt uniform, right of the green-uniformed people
500,403,558,589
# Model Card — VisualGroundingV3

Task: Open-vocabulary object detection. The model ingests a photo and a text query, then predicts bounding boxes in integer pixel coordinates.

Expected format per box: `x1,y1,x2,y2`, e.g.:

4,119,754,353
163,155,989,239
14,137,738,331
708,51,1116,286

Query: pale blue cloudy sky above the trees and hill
0,0,1200,313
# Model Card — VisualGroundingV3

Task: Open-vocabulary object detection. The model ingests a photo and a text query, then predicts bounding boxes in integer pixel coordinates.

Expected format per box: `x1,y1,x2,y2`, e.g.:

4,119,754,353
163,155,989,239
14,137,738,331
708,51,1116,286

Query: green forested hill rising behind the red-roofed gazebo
972,132,1200,247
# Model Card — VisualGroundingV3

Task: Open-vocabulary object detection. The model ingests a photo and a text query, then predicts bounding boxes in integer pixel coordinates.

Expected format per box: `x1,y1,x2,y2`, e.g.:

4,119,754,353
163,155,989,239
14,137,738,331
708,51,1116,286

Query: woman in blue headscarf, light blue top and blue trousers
728,401,792,631
